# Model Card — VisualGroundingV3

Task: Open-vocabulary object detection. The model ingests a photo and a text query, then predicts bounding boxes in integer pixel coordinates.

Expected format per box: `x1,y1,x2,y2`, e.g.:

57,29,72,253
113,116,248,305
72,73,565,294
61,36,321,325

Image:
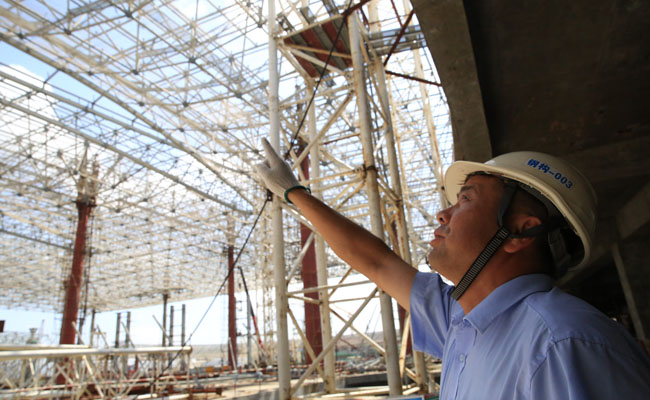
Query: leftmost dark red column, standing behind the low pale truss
59,199,95,344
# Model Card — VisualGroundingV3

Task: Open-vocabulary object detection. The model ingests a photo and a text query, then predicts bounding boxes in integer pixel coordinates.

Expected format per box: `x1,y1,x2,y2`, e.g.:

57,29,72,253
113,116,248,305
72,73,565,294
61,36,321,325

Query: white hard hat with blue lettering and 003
445,151,596,268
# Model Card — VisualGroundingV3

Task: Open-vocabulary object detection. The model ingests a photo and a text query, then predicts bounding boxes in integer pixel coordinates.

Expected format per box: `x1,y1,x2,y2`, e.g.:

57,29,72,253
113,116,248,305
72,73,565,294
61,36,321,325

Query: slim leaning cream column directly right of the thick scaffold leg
368,2,426,390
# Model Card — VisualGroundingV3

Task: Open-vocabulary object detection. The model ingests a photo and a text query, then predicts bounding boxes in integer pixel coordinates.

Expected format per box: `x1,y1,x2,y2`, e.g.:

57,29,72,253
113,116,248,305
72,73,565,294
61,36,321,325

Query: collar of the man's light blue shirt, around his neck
465,274,553,334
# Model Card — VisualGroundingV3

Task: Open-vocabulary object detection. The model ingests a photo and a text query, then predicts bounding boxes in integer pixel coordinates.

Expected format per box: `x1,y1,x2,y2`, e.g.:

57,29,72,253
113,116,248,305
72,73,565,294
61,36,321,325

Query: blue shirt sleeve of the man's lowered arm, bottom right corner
529,339,650,400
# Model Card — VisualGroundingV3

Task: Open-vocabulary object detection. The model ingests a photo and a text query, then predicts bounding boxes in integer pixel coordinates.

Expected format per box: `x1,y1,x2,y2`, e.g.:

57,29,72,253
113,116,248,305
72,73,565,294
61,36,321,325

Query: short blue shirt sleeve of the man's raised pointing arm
410,272,458,358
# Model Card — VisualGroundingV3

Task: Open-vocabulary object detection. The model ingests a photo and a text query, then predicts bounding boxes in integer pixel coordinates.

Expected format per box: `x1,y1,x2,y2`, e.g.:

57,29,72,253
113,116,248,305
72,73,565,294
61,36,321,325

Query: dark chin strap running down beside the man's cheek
451,182,517,300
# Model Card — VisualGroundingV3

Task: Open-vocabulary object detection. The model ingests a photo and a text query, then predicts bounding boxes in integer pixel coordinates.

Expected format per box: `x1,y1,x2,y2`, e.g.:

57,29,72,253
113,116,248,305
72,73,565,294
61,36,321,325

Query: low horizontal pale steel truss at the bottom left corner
0,346,195,399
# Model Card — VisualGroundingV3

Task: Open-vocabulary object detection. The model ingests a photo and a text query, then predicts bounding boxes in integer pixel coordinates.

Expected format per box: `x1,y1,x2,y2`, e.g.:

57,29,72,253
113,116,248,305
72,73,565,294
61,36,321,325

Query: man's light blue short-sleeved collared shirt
411,272,650,400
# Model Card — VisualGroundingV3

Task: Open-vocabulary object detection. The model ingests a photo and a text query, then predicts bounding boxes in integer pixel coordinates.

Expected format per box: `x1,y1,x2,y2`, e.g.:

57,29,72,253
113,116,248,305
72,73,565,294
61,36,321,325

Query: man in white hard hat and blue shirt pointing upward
256,141,650,399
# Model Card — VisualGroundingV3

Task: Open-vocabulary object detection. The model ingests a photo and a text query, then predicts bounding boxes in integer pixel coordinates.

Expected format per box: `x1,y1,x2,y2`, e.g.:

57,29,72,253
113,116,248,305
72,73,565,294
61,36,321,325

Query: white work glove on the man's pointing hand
255,139,309,203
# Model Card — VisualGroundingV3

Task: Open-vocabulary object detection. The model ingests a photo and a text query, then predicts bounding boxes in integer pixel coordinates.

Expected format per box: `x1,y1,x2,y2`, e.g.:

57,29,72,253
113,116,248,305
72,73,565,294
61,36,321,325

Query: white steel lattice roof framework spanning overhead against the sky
0,0,452,344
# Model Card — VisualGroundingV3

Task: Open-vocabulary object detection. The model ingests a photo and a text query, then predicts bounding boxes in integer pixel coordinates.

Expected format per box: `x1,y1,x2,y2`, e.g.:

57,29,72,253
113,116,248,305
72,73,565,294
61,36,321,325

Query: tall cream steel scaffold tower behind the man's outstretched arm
269,3,444,398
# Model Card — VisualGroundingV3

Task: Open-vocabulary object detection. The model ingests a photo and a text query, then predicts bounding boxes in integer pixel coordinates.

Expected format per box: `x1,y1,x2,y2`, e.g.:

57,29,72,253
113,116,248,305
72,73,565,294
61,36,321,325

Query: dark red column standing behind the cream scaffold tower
300,144,323,364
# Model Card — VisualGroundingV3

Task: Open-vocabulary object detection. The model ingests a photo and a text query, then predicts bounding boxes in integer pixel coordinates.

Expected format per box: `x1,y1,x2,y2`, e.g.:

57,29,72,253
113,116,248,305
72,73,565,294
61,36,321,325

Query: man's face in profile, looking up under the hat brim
428,175,503,284
